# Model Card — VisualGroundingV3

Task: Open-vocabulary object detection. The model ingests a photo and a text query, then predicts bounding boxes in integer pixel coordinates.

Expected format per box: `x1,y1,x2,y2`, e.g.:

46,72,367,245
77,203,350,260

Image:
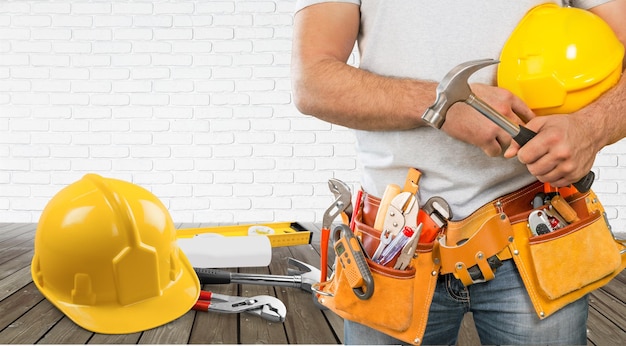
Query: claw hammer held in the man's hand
422,59,595,192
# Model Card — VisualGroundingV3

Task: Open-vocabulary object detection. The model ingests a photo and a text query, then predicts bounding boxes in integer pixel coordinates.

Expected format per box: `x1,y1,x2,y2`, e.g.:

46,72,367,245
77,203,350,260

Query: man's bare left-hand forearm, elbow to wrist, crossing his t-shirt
292,58,436,130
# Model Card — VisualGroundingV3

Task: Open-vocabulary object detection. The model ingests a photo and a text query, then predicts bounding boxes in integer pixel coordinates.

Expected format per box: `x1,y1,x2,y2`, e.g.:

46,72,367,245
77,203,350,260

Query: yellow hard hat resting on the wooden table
31,174,200,334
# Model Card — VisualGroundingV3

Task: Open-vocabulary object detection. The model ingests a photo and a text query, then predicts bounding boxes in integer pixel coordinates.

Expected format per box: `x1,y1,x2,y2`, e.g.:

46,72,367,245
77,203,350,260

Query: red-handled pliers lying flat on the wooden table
192,291,287,322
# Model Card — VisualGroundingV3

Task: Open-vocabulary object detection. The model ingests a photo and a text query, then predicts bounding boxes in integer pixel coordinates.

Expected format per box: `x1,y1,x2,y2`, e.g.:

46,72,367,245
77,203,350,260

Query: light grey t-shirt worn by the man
296,0,607,220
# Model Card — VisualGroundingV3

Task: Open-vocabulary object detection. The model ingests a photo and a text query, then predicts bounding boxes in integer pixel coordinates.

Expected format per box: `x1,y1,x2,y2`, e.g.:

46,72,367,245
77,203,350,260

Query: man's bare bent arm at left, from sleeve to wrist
291,3,426,130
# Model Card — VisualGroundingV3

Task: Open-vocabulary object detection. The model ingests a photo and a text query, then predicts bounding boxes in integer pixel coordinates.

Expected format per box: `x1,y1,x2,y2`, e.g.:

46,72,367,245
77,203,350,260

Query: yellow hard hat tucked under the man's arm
498,4,624,115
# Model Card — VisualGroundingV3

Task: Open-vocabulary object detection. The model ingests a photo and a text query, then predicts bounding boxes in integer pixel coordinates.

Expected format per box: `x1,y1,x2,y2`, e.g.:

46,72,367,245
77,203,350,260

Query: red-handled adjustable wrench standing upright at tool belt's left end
320,178,352,282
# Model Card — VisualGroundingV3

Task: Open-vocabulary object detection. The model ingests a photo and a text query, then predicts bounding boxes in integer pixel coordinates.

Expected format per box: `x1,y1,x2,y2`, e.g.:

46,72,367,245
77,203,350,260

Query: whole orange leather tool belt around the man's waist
316,171,626,344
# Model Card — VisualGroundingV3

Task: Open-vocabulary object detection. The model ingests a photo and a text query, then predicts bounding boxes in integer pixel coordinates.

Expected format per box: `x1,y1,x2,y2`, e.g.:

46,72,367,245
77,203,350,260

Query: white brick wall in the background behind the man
0,0,626,237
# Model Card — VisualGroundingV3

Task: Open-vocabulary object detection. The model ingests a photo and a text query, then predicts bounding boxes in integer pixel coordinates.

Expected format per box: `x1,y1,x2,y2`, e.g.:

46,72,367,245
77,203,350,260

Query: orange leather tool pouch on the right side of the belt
495,184,626,319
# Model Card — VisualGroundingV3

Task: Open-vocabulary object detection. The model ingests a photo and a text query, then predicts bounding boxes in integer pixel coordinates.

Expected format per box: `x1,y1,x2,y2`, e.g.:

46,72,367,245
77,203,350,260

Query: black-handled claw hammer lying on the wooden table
194,257,320,292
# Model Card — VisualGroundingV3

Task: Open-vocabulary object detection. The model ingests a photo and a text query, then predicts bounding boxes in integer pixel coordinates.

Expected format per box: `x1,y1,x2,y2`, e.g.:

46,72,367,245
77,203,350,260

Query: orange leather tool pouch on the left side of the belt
315,193,439,344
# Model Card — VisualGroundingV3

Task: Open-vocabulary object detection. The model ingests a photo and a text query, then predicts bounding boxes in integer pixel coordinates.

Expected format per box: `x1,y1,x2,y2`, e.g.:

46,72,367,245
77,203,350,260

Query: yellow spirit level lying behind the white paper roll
176,222,313,247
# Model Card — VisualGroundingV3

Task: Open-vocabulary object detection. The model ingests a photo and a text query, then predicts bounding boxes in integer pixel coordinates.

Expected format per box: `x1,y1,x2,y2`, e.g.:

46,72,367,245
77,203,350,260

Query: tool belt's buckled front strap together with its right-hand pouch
434,182,626,318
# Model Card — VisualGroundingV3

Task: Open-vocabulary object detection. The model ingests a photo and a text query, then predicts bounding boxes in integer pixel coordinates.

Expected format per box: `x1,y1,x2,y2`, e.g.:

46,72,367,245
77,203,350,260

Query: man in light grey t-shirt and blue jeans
292,0,626,344
